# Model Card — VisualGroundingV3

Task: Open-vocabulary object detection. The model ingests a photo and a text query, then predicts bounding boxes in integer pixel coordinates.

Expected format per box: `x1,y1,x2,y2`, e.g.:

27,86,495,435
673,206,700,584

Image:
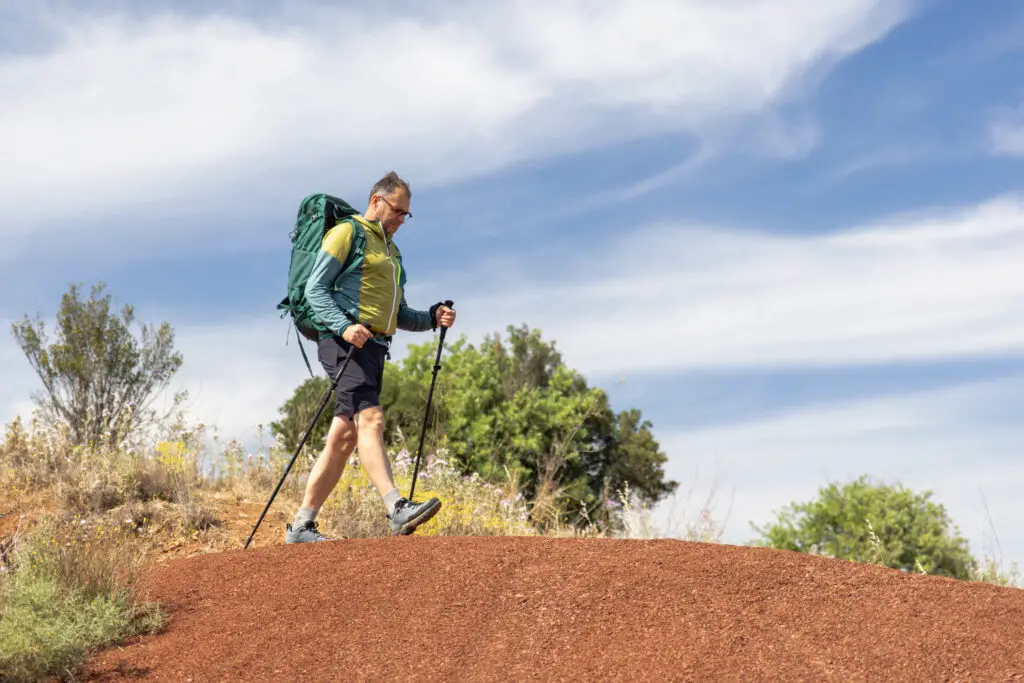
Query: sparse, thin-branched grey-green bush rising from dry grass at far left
11,283,185,447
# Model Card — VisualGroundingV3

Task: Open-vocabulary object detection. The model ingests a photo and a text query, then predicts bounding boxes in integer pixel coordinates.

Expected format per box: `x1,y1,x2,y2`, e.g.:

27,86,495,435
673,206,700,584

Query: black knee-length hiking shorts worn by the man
317,337,387,419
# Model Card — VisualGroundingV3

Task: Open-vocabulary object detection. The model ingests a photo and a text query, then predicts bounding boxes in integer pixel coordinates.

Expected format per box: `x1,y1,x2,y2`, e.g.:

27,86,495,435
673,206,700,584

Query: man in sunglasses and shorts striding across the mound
285,171,455,543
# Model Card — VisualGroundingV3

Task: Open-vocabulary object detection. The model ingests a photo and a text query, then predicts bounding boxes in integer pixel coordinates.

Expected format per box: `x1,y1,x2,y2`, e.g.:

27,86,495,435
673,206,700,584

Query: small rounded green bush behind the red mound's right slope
752,476,976,579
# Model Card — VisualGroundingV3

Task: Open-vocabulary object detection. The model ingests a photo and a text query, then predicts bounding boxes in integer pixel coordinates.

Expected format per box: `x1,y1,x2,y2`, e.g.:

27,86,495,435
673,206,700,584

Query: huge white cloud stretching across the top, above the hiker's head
0,0,906,250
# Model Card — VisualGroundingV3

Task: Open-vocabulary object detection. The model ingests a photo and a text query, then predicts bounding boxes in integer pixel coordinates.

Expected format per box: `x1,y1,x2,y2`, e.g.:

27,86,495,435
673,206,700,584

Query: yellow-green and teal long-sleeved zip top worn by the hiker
306,215,436,338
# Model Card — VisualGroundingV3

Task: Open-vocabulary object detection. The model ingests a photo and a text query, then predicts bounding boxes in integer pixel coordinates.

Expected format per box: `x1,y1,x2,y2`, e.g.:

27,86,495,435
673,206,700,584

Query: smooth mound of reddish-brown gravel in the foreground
86,537,1024,681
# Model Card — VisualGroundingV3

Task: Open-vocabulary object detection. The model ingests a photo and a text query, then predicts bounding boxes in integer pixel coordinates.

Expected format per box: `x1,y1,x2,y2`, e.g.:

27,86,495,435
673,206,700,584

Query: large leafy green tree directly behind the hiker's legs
271,326,678,520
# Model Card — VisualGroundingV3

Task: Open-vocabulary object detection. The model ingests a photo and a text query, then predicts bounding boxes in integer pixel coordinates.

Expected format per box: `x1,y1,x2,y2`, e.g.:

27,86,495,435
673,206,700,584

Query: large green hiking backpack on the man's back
278,193,366,375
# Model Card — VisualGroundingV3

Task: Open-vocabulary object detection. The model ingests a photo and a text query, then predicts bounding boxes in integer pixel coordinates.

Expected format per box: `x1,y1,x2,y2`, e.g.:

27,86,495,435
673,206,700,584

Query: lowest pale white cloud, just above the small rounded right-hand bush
658,376,1024,564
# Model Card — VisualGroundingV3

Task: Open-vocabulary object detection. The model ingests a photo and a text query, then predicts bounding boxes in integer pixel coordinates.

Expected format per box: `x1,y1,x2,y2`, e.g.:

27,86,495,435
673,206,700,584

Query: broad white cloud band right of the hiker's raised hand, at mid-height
452,198,1024,377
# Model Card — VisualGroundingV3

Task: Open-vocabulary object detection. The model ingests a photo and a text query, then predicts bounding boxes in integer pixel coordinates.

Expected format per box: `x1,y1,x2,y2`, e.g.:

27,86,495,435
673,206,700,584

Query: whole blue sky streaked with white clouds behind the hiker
0,0,1024,566
